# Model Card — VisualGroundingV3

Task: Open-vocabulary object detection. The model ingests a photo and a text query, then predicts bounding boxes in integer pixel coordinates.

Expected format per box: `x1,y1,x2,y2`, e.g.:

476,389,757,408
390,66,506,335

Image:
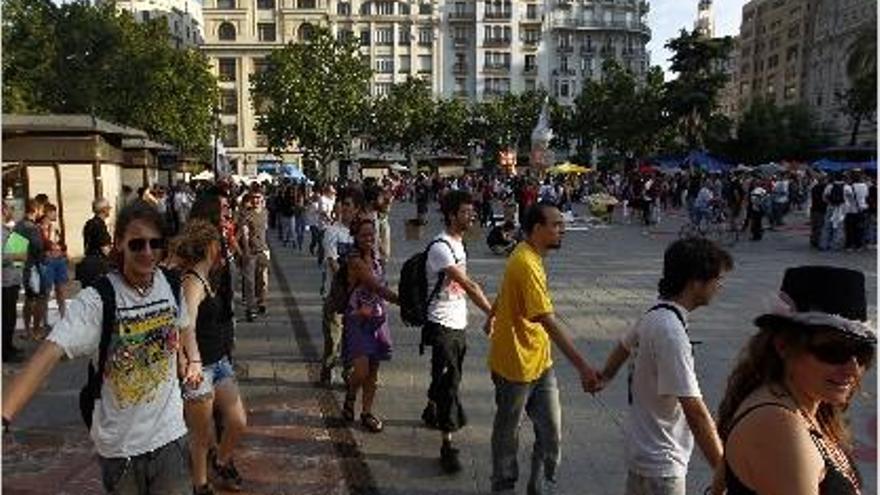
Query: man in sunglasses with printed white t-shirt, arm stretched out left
3,201,201,495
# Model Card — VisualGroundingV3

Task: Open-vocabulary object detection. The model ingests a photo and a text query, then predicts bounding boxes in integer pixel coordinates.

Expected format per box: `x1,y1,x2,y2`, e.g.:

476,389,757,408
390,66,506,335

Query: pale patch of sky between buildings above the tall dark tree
648,0,747,79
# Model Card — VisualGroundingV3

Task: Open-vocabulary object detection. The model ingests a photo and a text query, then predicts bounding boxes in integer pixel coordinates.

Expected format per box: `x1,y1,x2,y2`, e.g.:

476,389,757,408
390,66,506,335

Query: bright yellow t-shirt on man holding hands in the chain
489,242,553,383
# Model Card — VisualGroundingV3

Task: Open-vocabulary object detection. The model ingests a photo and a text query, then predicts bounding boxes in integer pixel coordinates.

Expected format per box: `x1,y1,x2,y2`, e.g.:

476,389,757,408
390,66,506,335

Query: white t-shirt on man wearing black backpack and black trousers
426,232,467,330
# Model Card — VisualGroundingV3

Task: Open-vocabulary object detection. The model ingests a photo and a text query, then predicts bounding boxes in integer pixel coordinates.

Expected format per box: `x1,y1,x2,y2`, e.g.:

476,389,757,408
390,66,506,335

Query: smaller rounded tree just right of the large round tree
369,77,435,161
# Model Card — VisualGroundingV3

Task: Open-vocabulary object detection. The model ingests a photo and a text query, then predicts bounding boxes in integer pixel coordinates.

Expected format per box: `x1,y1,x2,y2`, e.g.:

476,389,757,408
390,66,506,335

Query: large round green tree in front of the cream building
252,28,372,176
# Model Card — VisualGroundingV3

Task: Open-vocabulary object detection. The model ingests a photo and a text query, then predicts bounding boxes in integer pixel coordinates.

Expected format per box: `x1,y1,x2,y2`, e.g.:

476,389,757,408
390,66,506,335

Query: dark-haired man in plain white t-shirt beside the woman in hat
598,238,733,495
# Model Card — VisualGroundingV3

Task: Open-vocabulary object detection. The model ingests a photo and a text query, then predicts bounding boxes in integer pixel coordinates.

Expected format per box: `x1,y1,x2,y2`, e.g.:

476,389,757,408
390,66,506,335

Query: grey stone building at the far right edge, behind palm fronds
803,0,877,144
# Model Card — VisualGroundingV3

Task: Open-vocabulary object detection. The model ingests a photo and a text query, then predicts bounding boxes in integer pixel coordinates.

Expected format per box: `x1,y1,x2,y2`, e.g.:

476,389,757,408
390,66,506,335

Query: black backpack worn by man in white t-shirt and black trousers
397,239,458,327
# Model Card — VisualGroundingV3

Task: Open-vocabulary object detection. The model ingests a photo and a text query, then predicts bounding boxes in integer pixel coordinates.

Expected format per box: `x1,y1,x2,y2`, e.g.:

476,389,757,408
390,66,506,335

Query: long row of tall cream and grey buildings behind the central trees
202,0,651,173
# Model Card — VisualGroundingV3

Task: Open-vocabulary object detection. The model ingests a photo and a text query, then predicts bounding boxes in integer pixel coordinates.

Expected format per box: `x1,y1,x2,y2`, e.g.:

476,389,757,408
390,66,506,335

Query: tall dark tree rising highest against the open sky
665,30,733,149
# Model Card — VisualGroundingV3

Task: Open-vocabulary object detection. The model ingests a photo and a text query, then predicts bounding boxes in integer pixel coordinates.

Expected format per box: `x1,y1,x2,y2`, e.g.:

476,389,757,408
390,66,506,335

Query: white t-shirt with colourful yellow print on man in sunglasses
47,270,188,457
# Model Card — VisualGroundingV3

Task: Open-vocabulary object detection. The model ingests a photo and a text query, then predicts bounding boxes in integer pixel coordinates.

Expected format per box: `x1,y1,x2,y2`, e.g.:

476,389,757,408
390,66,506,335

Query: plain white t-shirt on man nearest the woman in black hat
621,301,702,477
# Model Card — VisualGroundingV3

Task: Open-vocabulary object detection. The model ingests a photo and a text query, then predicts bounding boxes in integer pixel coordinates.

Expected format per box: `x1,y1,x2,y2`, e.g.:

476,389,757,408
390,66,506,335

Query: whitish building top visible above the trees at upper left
109,0,205,48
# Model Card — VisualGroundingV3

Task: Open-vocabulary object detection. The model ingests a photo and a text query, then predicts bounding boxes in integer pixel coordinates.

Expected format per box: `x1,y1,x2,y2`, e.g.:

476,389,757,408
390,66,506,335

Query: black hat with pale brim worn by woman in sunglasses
755,266,877,344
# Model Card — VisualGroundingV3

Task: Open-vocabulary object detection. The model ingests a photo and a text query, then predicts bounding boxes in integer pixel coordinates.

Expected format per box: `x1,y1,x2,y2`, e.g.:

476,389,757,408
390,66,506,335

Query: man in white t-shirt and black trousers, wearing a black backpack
422,190,492,473
